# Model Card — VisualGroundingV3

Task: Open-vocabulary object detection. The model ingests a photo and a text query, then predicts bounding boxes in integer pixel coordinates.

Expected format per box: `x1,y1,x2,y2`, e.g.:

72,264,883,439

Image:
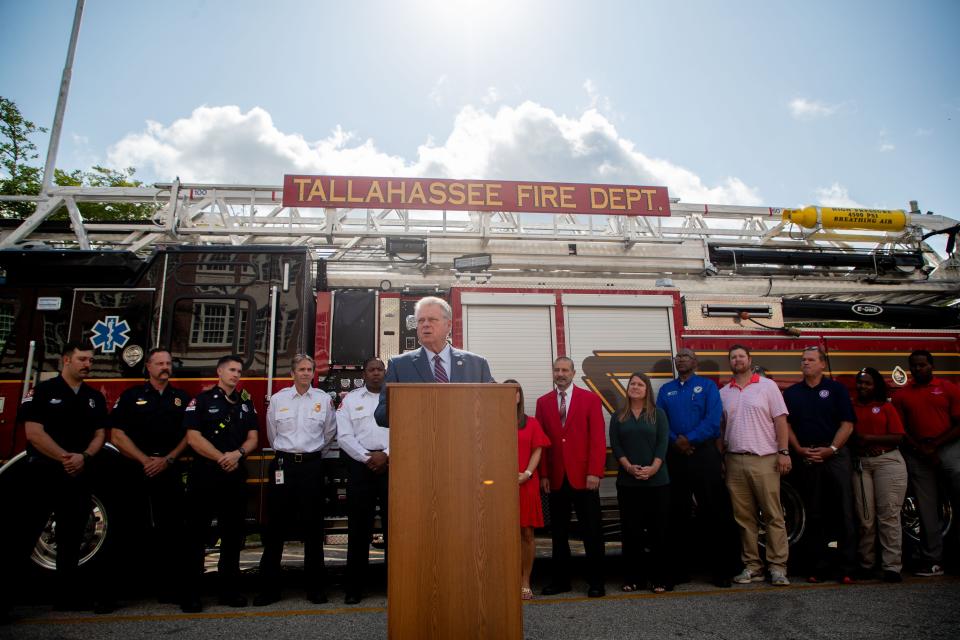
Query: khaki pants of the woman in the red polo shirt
853,449,907,573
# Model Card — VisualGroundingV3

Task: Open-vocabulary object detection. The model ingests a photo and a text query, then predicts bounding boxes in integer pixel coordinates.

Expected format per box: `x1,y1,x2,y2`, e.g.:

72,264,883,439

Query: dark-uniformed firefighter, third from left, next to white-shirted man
180,355,257,613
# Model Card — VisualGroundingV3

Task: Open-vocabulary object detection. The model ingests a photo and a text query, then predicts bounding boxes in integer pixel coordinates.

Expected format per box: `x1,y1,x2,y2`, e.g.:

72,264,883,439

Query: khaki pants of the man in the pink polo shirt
725,453,789,575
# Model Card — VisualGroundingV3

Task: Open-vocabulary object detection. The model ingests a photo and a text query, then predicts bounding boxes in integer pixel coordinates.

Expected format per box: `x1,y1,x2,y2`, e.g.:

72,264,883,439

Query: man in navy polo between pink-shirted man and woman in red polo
783,347,857,584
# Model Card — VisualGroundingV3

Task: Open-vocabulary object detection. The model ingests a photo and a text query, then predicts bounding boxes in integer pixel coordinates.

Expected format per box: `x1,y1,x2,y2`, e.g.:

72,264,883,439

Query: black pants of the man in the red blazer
550,477,604,588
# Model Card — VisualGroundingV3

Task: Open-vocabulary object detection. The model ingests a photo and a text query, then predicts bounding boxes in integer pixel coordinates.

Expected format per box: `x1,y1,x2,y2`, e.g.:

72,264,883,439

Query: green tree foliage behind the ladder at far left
0,96,157,222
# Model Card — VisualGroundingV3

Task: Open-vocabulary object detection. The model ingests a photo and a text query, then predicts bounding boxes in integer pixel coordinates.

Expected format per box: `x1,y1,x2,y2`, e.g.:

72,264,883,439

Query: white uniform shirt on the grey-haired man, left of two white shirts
267,386,337,453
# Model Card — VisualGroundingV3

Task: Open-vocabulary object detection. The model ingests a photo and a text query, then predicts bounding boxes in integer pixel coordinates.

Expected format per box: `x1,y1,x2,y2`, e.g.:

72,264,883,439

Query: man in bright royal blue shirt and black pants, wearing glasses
657,348,738,587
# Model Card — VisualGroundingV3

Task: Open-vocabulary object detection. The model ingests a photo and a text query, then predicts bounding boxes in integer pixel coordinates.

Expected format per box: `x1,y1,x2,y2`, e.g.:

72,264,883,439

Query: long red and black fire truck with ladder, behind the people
0,176,960,568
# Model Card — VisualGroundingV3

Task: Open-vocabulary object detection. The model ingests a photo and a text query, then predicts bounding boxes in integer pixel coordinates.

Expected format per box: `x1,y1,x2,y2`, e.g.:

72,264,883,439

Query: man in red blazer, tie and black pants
536,357,607,598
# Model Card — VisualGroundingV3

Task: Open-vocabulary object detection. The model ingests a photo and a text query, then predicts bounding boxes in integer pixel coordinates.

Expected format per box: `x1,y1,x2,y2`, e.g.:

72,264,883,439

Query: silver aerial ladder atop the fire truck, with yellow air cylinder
0,181,960,304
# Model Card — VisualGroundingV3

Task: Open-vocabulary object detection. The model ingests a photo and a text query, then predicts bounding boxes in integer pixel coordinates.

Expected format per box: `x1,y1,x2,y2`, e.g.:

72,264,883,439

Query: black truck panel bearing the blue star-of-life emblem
68,288,156,378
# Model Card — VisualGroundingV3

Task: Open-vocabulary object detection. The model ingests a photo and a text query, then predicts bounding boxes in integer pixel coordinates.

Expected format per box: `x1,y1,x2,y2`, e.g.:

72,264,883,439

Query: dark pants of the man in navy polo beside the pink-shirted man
793,448,858,577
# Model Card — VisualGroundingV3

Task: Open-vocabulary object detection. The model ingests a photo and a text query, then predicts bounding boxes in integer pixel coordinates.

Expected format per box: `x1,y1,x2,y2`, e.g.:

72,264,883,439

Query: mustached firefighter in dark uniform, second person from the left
110,348,190,602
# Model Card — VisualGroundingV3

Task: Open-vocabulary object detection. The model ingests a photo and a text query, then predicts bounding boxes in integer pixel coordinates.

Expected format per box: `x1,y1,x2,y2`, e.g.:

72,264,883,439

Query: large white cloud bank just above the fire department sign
109,102,760,205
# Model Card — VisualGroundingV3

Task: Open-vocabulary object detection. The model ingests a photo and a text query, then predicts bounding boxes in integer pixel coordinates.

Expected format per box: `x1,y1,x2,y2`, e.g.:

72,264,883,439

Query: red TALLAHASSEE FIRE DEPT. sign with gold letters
283,175,670,216
